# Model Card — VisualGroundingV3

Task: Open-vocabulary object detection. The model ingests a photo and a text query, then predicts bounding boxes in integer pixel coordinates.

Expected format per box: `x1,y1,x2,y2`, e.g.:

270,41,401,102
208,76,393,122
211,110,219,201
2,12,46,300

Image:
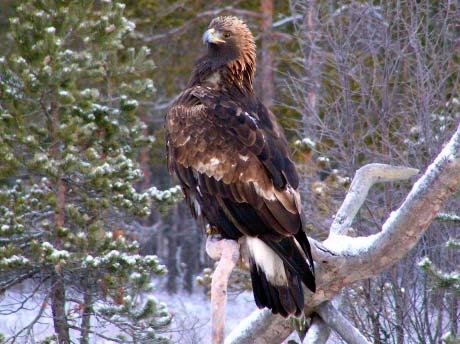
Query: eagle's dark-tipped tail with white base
246,237,315,317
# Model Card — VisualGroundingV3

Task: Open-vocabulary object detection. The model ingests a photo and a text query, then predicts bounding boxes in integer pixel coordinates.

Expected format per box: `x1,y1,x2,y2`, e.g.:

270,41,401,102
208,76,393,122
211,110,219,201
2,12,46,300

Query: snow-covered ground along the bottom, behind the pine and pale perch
0,290,256,344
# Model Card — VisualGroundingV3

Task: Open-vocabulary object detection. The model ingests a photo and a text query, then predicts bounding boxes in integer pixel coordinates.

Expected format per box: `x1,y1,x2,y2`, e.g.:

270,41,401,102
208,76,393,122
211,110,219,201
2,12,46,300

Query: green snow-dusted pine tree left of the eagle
0,0,180,343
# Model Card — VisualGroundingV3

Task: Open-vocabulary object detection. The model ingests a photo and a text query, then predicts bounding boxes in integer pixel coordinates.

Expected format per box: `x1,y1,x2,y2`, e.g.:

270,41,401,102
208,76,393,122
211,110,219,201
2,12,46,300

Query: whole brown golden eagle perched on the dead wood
166,17,315,316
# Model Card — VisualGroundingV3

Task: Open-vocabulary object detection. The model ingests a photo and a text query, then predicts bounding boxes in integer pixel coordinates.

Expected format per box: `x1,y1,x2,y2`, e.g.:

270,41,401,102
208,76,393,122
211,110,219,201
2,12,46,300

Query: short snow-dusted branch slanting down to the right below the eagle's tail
315,302,370,344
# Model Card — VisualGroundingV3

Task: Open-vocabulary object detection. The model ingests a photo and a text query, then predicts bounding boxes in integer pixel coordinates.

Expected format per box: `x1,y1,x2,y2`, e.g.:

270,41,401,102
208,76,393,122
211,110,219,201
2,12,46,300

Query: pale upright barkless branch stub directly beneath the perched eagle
206,236,240,344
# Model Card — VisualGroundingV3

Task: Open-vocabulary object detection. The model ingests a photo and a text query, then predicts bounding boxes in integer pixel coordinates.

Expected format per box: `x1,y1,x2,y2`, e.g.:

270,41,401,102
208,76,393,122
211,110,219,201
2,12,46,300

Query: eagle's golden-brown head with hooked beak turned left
203,17,256,77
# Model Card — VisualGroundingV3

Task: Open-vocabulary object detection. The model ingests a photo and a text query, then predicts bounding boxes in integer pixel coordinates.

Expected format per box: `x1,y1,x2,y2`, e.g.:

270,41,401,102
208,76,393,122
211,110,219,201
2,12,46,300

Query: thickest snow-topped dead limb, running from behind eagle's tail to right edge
226,126,460,344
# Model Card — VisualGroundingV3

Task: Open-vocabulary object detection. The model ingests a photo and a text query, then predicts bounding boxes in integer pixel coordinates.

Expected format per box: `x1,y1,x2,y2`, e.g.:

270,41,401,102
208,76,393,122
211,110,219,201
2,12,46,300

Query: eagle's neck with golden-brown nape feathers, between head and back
189,58,255,96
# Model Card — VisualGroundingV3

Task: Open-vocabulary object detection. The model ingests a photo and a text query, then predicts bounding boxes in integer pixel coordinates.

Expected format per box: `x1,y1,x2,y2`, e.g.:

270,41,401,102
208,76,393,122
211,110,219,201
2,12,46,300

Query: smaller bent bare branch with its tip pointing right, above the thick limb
329,164,419,236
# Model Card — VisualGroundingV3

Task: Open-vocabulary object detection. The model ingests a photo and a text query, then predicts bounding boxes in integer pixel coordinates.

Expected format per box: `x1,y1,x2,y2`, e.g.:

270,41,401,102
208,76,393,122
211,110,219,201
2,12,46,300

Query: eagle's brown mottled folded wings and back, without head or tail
166,88,301,237
